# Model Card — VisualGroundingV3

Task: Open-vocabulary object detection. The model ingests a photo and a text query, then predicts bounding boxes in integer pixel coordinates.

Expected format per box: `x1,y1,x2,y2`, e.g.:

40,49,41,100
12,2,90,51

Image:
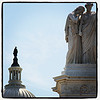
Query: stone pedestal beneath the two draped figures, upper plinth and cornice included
52,64,96,97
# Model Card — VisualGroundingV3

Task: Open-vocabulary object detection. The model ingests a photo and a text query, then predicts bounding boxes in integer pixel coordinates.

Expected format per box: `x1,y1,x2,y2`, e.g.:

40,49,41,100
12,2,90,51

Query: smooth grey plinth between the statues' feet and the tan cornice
62,64,96,77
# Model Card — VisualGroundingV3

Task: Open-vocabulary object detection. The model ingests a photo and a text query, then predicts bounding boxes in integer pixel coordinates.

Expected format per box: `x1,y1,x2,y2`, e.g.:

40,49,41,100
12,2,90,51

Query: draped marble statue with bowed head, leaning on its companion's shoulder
65,6,85,64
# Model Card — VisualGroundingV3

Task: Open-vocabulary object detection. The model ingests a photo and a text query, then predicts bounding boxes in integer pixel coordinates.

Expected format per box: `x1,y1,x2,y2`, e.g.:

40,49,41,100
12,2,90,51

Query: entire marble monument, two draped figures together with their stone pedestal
52,3,97,97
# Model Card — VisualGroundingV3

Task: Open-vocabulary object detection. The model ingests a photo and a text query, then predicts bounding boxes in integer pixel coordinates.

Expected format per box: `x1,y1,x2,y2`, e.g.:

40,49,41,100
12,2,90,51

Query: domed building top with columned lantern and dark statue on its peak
3,47,35,98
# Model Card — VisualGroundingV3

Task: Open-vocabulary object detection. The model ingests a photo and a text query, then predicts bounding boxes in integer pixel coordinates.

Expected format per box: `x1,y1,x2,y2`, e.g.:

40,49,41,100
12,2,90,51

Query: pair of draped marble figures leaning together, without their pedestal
65,3,97,64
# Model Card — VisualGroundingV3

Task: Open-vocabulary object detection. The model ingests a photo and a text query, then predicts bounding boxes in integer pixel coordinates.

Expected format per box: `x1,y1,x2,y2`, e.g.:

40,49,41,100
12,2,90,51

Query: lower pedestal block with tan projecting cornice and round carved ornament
52,75,96,97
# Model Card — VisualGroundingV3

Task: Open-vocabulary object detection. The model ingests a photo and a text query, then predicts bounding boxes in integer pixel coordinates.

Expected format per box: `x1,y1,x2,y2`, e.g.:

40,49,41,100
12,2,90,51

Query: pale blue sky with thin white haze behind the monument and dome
3,3,96,97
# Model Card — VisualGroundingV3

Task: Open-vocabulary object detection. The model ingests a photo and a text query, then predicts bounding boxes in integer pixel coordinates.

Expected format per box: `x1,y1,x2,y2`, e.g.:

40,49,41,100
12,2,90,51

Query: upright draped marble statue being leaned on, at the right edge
79,3,96,64
